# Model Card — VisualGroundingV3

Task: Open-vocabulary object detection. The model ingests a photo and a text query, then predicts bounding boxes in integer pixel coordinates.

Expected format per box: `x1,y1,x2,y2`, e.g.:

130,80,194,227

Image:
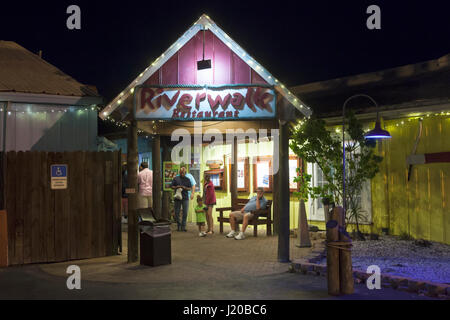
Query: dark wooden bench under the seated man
216,198,273,237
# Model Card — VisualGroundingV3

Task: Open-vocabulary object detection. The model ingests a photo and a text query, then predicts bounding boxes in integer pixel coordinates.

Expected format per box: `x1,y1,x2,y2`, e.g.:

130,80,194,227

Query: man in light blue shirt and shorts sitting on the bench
226,187,267,240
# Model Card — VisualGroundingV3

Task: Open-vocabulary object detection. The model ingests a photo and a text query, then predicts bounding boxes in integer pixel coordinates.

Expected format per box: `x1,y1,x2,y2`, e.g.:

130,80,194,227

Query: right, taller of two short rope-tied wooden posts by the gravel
335,207,354,294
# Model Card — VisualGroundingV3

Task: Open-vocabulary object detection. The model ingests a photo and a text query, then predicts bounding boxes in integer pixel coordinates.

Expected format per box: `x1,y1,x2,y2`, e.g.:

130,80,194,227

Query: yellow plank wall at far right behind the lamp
371,115,450,244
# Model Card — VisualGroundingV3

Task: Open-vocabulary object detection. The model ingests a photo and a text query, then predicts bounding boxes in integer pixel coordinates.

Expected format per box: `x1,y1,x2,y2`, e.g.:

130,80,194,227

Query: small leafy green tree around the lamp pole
290,112,383,238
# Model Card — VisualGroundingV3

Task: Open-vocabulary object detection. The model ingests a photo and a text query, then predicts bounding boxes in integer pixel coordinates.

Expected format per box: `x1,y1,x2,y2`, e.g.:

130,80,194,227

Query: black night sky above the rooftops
0,0,450,101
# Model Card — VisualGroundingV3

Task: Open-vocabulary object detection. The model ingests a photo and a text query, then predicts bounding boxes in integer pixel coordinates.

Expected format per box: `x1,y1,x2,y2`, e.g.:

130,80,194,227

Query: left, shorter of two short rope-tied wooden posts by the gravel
327,208,340,296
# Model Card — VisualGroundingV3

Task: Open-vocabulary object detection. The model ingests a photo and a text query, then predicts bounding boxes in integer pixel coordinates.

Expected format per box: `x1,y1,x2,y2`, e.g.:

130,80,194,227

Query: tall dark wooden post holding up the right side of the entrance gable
275,120,290,262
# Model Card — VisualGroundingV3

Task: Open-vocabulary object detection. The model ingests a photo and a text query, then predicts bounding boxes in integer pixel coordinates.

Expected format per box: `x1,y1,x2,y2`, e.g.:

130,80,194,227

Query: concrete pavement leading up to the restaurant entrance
0,225,438,300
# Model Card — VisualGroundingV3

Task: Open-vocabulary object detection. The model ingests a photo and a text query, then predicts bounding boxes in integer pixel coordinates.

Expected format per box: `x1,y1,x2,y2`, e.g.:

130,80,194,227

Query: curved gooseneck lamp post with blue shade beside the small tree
342,93,391,215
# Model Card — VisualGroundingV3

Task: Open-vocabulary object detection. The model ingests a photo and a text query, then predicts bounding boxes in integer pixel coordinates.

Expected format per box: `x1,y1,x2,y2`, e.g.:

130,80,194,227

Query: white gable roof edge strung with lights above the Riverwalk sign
99,14,312,119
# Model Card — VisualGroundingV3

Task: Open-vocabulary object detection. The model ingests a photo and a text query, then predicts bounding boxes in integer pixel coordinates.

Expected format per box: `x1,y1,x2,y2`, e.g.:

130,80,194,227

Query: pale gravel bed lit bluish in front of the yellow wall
346,236,450,284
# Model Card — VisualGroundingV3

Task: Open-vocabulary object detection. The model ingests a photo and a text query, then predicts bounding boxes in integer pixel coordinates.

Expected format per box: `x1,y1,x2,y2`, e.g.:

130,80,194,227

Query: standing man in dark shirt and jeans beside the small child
170,167,192,231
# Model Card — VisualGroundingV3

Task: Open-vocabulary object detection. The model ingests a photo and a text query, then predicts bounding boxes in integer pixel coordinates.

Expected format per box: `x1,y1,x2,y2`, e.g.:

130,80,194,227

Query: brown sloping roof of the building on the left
0,40,100,97
